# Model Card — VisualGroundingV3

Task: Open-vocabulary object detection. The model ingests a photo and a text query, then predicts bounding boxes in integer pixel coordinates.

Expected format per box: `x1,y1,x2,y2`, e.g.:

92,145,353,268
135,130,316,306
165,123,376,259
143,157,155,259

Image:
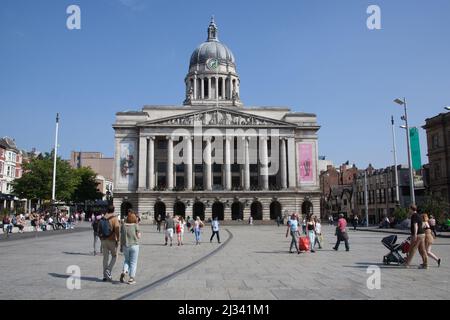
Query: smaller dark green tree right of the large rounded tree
72,168,103,203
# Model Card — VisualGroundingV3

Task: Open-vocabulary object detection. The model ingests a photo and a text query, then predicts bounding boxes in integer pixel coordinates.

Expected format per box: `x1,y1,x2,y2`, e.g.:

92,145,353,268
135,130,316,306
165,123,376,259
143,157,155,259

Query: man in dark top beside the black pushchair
404,205,428,269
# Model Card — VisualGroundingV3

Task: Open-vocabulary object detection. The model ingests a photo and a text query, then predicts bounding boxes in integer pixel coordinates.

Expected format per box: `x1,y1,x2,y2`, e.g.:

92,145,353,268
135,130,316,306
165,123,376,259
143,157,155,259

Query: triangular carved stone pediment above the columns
139,107,296,128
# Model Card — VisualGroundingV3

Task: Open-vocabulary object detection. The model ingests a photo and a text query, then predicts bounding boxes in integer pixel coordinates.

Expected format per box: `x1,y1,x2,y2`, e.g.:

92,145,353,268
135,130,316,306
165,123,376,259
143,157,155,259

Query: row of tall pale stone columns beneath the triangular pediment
138,135,296,191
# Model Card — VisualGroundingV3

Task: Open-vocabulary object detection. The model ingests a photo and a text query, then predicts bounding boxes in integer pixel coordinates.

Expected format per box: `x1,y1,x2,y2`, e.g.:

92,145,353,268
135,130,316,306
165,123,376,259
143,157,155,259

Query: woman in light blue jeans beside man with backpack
120,212,141,284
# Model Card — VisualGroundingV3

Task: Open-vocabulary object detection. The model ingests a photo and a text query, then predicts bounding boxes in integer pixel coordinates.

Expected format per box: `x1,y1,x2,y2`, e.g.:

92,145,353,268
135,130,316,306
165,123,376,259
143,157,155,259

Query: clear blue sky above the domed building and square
0,0,450,167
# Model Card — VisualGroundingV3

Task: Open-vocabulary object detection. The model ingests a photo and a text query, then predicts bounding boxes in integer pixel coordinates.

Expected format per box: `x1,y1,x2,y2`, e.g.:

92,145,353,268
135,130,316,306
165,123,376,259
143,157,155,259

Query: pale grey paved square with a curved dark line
0,225,450,300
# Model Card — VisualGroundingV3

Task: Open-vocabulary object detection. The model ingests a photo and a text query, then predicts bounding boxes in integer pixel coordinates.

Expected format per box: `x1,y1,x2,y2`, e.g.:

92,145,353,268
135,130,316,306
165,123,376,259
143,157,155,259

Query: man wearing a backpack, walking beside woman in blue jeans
98,205,120,281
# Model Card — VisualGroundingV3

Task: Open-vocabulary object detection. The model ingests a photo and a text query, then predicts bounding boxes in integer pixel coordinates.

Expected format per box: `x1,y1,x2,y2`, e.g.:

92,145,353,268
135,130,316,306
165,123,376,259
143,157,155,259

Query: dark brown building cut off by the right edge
422,112,450,202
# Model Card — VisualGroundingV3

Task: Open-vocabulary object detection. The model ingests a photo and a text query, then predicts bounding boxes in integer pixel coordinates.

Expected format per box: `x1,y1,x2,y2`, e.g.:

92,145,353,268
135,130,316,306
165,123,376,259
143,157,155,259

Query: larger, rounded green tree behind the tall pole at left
12,152,80,201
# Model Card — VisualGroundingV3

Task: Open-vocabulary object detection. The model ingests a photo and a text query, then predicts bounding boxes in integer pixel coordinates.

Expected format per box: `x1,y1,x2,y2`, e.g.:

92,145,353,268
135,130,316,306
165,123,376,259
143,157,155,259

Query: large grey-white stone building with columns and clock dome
113,19,320,221
